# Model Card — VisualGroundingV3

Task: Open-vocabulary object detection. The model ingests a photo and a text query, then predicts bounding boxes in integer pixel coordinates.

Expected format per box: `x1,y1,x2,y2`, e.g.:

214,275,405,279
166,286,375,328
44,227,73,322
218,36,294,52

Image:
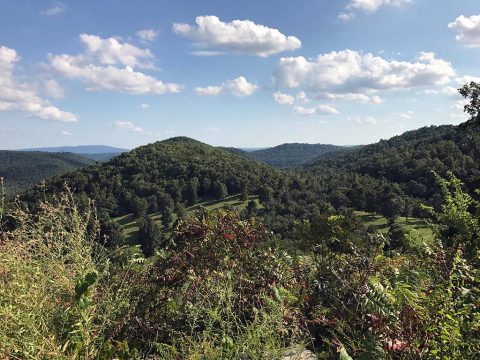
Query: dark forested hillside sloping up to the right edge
306,125,480,199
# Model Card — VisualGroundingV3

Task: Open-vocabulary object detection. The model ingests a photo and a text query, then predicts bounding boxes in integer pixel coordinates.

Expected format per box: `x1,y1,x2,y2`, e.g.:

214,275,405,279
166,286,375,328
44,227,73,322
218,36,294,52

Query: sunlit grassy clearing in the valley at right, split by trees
355,211,433,243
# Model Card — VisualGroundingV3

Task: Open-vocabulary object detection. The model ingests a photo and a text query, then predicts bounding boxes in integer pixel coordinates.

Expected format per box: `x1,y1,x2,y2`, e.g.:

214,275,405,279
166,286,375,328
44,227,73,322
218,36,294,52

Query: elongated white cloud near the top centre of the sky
173,16,302,57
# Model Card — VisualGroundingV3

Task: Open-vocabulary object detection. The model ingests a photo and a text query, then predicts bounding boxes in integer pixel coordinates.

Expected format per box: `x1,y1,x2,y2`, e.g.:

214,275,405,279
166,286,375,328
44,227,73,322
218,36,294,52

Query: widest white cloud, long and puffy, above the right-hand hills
274,49,455,93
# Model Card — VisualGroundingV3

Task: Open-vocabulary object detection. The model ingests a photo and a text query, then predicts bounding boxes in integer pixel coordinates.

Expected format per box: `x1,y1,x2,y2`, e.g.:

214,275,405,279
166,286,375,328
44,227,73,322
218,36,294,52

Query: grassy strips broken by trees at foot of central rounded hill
114,194,263,240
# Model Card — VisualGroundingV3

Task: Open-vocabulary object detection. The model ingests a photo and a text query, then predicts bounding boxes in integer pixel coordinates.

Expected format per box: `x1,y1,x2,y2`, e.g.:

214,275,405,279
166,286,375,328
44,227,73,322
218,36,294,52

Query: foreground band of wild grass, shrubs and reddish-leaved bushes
0,175,480,360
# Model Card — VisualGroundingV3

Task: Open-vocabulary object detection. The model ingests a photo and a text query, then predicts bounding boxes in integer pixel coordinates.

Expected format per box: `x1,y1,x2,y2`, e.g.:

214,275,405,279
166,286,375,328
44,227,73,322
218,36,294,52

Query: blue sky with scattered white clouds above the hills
0,0,480,149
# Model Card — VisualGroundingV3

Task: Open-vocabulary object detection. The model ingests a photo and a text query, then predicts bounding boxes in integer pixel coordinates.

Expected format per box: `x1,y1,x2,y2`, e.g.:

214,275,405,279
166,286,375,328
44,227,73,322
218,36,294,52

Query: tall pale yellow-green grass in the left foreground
0,193,138,359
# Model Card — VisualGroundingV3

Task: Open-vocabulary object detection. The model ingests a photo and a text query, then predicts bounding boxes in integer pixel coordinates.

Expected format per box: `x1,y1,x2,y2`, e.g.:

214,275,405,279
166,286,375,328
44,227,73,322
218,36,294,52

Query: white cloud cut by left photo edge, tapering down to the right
0,46,78,121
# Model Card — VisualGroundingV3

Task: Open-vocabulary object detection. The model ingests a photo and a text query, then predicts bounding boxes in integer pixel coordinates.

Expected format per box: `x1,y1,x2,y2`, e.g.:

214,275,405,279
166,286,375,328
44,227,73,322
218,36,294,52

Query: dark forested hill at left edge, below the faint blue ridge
0,150,93,196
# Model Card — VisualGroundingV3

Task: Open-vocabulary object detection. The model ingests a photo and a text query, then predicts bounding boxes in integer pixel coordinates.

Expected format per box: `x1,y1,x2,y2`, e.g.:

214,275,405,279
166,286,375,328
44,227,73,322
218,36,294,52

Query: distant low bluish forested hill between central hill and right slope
246,143,347,168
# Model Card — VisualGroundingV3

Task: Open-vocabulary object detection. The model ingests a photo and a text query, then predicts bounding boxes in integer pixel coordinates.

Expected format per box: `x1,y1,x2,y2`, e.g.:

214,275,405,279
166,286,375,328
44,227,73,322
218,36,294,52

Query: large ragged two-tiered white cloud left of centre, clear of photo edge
50,34,182,95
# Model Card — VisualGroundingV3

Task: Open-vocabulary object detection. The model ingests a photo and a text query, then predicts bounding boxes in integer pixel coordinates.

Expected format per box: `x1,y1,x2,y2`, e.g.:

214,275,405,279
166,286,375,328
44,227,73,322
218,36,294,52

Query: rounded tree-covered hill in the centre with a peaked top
25,137,281,216
